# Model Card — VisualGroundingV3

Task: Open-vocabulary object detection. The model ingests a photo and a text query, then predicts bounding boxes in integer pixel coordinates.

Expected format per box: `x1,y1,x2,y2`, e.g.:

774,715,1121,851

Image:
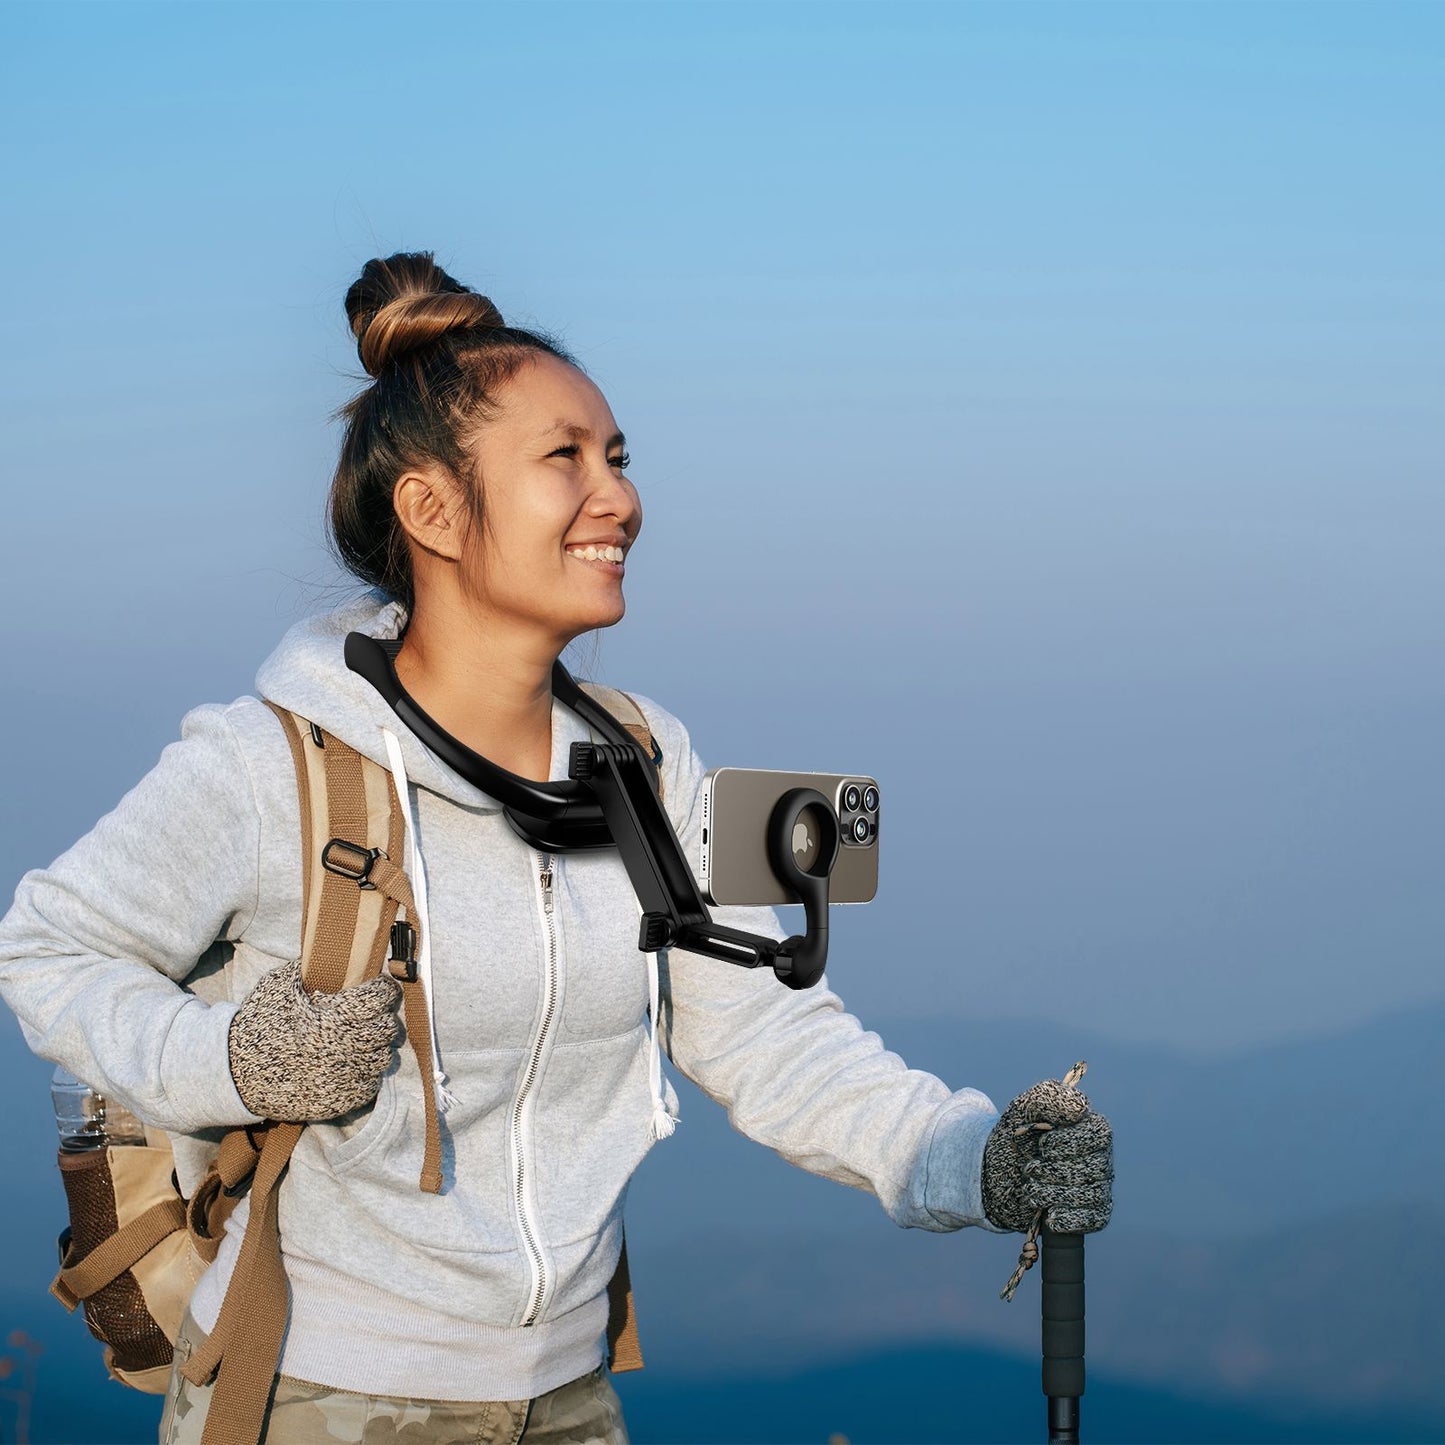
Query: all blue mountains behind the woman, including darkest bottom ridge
0,1006,1445,1445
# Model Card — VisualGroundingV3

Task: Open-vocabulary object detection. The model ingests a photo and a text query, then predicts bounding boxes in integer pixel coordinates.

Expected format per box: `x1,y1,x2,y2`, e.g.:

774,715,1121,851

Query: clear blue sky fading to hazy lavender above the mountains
0,3,1445,1438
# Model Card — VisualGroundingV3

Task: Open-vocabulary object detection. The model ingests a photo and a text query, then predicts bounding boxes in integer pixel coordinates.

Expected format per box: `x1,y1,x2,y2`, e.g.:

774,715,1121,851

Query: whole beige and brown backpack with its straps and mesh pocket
51,683,662,1445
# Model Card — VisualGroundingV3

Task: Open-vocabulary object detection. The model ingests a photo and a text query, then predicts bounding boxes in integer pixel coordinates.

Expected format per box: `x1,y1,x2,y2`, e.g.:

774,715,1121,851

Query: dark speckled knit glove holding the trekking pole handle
983,1079,1114,1234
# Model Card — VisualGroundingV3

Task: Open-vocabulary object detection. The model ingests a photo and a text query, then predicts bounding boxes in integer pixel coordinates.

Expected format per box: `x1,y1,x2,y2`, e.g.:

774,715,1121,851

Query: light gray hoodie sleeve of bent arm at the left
0,707,260,1133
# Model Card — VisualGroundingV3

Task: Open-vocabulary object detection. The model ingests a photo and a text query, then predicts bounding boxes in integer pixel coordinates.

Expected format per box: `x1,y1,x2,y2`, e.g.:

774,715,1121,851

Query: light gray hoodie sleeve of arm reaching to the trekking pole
637,698,998,1231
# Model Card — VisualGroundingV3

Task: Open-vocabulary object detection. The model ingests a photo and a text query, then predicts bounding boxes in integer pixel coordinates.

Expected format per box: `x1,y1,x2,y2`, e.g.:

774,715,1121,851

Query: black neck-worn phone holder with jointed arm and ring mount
345,633,840,988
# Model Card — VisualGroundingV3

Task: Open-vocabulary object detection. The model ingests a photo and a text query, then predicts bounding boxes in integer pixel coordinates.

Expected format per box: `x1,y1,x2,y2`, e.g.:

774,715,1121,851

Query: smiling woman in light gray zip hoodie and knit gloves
0,254,1111,1445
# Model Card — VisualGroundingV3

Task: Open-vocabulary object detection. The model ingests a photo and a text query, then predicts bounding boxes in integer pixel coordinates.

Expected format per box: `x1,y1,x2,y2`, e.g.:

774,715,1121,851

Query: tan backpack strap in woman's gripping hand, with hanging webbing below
182,702,442,1445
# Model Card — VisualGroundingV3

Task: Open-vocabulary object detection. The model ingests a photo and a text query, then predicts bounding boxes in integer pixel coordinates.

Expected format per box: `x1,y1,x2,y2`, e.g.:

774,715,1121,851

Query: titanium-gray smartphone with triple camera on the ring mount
698,767,879,905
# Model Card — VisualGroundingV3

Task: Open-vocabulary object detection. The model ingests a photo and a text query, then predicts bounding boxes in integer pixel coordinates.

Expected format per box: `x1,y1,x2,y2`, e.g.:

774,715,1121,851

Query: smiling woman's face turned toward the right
462,353,642,650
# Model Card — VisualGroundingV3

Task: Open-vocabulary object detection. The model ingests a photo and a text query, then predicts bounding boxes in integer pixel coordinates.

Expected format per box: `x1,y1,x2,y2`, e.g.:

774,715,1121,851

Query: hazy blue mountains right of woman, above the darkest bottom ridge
629,1006,1445,1439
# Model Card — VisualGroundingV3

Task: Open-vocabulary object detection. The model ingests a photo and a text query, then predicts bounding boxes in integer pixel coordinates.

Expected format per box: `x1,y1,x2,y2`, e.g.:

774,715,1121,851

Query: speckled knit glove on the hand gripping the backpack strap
230,962,402,1124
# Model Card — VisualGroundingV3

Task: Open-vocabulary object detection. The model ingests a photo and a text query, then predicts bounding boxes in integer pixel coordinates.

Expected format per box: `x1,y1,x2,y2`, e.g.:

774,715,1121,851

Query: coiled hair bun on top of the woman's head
347,251,506,376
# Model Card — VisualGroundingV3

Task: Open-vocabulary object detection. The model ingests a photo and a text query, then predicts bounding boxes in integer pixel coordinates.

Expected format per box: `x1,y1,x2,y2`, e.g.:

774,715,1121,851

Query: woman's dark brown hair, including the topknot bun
327,251,581,614
